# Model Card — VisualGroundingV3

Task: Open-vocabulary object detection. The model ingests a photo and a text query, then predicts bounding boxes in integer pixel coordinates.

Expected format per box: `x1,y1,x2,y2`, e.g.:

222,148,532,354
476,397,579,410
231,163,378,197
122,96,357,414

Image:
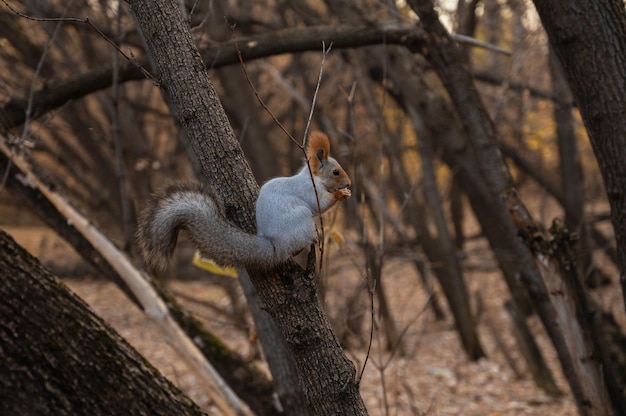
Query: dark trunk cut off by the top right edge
534,0,626,308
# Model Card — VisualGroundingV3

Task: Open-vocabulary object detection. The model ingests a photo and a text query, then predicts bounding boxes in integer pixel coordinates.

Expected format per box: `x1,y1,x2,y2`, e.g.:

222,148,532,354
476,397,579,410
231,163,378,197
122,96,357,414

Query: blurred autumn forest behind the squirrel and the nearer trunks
0,0,625,415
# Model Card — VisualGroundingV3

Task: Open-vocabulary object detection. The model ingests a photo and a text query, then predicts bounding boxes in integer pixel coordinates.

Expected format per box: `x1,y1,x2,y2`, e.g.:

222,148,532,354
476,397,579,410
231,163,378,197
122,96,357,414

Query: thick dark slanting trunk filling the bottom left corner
0,230,203,415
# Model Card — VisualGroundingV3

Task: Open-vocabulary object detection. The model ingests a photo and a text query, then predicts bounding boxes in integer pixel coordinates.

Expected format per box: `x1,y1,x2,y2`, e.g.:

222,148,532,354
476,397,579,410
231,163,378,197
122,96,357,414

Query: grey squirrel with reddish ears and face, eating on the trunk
137,132,351,269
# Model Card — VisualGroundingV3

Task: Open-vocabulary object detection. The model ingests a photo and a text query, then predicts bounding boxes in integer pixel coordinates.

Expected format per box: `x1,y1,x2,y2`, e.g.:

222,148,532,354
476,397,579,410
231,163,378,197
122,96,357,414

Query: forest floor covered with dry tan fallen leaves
8,224,623,416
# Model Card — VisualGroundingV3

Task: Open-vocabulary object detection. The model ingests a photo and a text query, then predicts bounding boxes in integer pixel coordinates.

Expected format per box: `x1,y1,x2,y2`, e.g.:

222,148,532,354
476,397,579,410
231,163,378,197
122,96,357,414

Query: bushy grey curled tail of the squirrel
137,184,280,268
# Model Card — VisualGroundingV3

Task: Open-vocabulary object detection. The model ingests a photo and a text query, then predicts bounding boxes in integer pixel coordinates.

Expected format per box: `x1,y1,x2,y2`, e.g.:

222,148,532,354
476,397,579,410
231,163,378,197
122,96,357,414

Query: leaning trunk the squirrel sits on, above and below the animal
130,0,367,415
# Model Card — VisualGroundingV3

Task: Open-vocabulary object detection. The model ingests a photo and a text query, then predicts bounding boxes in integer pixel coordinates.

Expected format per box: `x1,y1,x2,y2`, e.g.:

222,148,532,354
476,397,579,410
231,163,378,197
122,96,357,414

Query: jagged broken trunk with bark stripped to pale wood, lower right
503,191,626,416
